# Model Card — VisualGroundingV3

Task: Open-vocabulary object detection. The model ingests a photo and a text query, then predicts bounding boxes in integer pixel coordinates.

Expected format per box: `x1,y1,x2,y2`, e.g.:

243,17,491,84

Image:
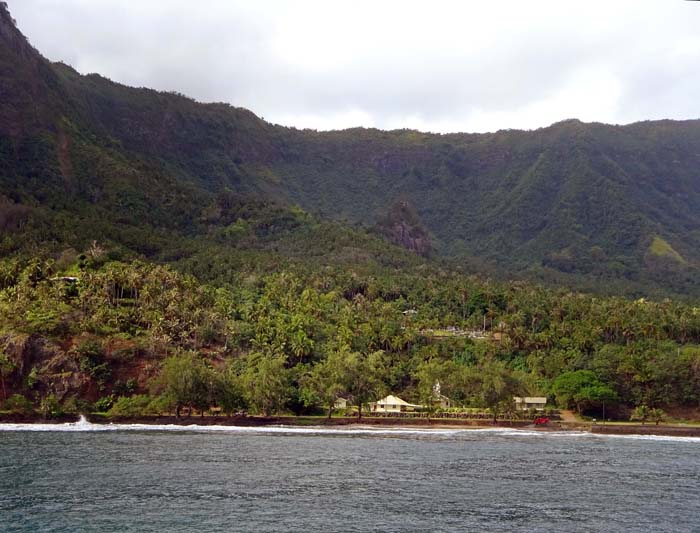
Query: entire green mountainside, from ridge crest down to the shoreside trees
0,3,700,416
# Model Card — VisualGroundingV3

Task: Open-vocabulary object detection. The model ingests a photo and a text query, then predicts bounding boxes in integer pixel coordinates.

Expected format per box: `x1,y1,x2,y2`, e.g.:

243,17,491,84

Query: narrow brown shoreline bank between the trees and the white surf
0,413,700,438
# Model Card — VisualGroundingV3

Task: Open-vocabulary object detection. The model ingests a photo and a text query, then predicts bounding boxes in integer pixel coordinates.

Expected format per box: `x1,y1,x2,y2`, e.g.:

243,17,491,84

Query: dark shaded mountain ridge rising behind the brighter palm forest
0,2,700,296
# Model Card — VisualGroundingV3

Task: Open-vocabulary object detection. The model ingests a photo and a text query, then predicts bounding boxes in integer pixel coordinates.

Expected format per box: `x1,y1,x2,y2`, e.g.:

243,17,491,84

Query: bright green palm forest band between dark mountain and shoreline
0,245,700,414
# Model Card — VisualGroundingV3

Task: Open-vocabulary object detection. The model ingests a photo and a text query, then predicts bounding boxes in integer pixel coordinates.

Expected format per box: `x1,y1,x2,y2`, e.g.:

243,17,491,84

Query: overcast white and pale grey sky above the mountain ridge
8,0,700,132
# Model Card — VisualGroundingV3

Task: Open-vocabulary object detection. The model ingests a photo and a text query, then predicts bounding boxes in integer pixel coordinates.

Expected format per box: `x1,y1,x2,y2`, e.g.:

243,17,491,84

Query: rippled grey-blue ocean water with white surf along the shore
0,422,700,532
